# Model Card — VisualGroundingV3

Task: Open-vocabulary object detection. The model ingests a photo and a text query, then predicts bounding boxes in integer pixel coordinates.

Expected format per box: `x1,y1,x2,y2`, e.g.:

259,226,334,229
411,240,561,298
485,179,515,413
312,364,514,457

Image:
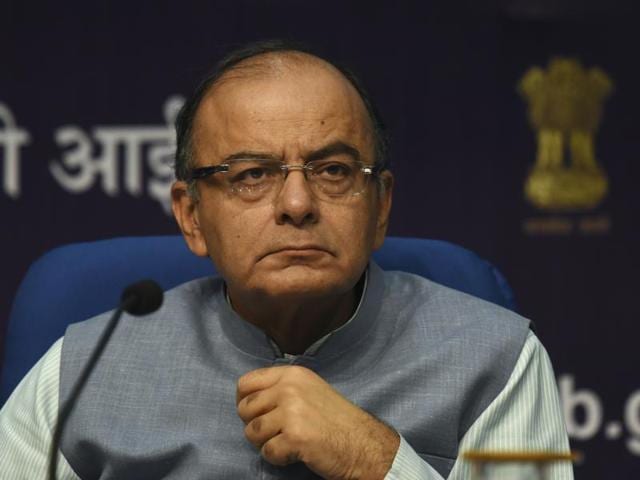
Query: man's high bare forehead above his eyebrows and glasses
193,57,373,164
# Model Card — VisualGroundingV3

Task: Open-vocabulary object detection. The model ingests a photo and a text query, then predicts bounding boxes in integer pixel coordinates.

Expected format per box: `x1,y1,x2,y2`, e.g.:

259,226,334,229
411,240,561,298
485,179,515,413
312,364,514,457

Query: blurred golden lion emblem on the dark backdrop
518,58,613,211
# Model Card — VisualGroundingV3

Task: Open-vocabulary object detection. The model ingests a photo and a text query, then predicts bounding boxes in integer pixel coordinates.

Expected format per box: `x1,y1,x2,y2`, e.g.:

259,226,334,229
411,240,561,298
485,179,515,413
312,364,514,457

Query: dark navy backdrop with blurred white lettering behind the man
0,0,640,479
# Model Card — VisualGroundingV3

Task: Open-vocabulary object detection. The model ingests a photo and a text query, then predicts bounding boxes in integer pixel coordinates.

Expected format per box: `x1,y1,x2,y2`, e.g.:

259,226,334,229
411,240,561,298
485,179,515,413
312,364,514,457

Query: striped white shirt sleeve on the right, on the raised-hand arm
386,332,573,480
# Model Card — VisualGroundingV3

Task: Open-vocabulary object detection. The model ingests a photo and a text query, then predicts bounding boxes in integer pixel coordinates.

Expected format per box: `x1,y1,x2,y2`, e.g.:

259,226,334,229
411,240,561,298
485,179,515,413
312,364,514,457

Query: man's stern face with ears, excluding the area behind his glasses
173,61,392,299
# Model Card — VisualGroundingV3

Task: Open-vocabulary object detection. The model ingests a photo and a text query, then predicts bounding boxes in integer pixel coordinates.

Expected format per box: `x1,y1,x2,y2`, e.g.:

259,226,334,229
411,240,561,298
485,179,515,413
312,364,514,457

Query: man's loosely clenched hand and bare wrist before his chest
236,366,400,480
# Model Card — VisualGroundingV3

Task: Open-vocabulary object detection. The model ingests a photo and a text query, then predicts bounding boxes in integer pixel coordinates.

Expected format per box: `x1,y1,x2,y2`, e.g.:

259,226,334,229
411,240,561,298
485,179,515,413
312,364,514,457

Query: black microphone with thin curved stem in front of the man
48,280,164,480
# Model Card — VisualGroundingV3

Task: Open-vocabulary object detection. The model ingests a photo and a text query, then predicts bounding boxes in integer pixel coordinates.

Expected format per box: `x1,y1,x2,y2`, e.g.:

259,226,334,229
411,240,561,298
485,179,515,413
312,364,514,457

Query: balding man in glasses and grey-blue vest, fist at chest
0,43,572,479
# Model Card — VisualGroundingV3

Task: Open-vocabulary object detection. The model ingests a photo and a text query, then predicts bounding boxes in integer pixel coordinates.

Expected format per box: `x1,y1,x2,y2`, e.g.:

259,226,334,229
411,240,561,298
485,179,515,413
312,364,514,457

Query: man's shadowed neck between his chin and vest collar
229,276,364,355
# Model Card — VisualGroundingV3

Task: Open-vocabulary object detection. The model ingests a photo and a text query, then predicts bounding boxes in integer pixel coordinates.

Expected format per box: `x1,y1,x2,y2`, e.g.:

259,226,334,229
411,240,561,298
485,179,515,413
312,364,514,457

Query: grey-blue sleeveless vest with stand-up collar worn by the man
60,263,529,480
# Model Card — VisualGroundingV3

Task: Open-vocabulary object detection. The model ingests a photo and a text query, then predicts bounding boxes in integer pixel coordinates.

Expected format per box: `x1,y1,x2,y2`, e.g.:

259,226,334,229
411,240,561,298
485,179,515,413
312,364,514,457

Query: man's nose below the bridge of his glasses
275,168,318,226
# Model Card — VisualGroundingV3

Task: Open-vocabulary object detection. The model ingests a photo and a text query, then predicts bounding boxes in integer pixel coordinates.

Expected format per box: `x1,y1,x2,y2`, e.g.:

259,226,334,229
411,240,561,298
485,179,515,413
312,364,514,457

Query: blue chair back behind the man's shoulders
0,236,515,405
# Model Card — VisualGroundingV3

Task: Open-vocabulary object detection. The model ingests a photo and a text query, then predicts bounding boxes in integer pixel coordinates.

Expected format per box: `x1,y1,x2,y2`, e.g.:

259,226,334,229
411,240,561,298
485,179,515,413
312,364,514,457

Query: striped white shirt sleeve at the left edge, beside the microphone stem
0,339,80,480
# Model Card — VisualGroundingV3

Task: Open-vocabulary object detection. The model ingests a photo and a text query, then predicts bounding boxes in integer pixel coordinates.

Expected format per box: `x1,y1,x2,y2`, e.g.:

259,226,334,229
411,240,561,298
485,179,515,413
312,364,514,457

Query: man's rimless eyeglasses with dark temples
187,158,379,202
